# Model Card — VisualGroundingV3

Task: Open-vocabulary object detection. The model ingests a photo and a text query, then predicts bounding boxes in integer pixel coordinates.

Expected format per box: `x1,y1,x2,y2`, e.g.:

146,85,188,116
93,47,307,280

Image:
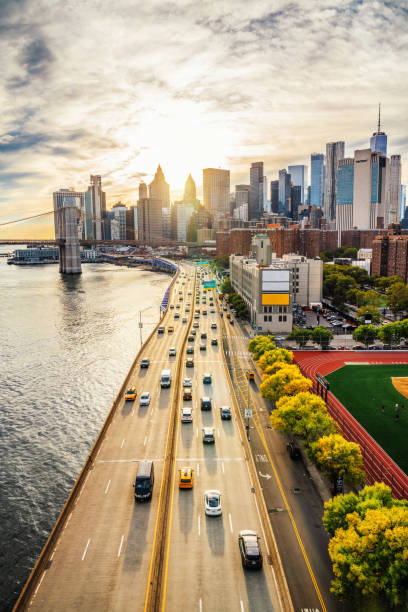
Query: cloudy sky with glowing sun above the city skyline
0,0,408,238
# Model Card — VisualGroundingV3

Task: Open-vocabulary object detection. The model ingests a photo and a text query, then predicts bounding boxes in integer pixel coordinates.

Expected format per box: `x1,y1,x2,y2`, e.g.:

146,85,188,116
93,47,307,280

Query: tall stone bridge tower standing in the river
54,190,82,274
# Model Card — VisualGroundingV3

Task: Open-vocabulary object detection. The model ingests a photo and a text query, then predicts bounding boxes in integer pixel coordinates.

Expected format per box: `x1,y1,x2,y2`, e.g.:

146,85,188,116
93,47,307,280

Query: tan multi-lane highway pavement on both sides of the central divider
22,267,284,612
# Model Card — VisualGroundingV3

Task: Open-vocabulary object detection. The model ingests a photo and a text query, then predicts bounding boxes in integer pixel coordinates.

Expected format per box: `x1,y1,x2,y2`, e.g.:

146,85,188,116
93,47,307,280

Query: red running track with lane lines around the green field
294,351,408,499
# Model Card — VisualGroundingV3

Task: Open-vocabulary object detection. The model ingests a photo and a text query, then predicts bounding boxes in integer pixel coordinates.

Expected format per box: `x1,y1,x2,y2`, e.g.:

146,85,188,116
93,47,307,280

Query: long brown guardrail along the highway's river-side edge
13,269,180,612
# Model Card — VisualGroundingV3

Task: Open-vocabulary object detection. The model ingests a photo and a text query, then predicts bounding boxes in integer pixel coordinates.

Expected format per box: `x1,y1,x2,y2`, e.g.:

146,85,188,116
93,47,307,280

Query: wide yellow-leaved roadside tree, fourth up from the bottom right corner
271,392,338,444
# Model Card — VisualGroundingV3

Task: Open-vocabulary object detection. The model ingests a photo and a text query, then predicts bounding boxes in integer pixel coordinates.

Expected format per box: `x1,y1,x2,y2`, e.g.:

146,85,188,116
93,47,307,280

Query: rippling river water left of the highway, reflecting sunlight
0,246,171,610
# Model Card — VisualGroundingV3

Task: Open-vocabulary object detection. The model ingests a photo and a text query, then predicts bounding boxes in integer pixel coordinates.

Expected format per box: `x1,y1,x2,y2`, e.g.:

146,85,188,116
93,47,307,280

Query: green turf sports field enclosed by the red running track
326,365,408,474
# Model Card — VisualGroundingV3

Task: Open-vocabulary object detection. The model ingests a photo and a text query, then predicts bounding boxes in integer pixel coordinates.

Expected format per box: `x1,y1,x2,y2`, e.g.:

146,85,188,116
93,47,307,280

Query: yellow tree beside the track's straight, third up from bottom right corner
309,434,365,490
